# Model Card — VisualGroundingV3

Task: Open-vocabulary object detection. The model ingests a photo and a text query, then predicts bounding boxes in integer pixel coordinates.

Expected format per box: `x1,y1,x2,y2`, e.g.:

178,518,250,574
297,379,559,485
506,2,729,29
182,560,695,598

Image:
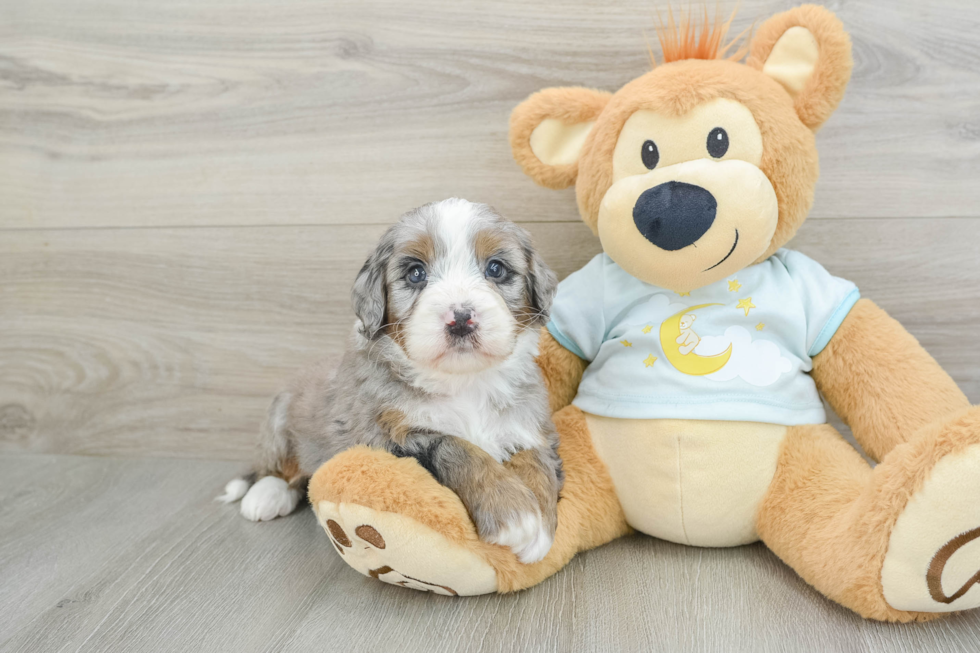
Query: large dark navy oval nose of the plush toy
633,181,718,252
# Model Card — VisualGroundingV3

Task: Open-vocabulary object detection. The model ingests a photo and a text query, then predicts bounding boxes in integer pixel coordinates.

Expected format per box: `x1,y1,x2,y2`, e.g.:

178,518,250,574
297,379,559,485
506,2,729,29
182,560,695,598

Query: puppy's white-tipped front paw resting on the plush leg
470,479,555,564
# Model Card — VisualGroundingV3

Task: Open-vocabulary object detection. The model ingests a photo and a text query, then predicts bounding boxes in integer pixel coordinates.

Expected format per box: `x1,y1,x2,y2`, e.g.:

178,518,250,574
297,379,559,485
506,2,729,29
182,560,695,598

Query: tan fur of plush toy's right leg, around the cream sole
757,408,980,621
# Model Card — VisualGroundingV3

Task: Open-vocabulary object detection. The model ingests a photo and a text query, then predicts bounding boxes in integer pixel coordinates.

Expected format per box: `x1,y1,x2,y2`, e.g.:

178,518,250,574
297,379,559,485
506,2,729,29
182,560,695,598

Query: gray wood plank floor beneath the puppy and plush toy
0,454,980,653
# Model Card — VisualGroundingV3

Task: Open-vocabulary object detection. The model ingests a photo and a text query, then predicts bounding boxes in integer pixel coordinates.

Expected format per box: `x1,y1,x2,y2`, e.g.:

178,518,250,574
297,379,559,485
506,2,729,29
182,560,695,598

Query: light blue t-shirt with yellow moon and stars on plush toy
548,249,860,425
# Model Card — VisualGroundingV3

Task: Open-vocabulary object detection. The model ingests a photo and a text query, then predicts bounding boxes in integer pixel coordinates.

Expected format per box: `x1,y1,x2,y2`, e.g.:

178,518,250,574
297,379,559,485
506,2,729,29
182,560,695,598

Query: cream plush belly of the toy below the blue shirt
586,414,786,546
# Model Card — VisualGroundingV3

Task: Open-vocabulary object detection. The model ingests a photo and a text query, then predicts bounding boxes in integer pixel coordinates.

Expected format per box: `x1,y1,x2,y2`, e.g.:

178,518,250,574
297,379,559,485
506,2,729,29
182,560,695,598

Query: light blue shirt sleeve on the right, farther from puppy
775,250,861,358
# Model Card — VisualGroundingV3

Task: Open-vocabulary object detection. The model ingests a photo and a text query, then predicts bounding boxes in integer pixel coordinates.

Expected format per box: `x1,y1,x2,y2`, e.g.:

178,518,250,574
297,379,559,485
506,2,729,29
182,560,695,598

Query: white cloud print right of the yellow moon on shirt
694,326,793,387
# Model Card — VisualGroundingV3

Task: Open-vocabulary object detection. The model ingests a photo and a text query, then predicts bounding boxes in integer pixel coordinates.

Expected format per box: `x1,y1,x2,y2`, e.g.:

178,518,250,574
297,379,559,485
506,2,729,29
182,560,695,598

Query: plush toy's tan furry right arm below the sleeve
811,299,970,460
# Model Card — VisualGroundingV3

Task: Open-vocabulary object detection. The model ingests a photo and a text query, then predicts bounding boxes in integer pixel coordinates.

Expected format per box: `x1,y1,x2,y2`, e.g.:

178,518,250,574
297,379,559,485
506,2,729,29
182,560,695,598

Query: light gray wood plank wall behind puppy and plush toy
0,0,980,459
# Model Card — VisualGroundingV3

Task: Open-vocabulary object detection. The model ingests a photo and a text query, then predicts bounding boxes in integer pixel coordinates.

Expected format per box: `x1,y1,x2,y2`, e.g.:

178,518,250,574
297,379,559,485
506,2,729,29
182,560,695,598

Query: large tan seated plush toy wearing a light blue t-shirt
310,6,980,621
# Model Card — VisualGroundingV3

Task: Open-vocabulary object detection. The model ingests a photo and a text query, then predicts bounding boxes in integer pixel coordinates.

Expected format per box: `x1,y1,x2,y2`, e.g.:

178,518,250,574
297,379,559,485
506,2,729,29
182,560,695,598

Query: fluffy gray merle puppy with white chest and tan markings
218,199,564,563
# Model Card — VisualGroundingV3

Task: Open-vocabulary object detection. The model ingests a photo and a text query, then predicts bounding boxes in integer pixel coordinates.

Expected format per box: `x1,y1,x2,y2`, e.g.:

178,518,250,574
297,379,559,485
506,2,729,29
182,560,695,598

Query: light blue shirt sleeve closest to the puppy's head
548,254,606,361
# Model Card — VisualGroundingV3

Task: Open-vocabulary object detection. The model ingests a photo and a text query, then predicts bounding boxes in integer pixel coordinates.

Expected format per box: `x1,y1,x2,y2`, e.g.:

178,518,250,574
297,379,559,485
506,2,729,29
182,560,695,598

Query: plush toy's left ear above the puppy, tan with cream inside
510,87,612,190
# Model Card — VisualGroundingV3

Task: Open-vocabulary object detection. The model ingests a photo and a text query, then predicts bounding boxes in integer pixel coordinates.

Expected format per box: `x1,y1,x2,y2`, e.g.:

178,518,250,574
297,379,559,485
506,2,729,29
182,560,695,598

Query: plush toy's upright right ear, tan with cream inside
746,5,854,131
